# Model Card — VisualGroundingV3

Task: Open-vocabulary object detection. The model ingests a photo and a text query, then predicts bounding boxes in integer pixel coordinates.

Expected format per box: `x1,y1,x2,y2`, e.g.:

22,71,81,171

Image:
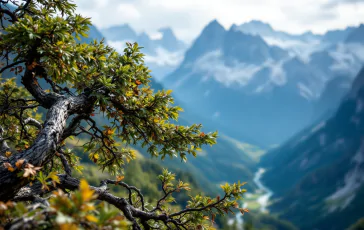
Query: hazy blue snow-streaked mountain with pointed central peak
163,20,364,147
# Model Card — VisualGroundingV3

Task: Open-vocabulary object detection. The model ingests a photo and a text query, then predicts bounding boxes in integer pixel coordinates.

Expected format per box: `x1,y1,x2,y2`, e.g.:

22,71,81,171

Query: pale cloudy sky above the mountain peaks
75,0,364,41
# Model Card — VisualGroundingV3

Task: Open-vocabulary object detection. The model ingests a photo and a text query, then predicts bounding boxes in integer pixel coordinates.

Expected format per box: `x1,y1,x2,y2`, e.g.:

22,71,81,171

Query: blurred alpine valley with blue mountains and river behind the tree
0,4,364,230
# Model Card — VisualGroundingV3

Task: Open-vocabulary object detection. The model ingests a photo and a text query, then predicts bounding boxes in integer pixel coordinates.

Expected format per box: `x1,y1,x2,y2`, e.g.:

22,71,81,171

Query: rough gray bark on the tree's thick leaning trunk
0,94,92,200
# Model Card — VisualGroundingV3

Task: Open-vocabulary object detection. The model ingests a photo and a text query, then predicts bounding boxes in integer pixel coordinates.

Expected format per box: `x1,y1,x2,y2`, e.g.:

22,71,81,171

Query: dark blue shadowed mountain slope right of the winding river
260,68,364,230
